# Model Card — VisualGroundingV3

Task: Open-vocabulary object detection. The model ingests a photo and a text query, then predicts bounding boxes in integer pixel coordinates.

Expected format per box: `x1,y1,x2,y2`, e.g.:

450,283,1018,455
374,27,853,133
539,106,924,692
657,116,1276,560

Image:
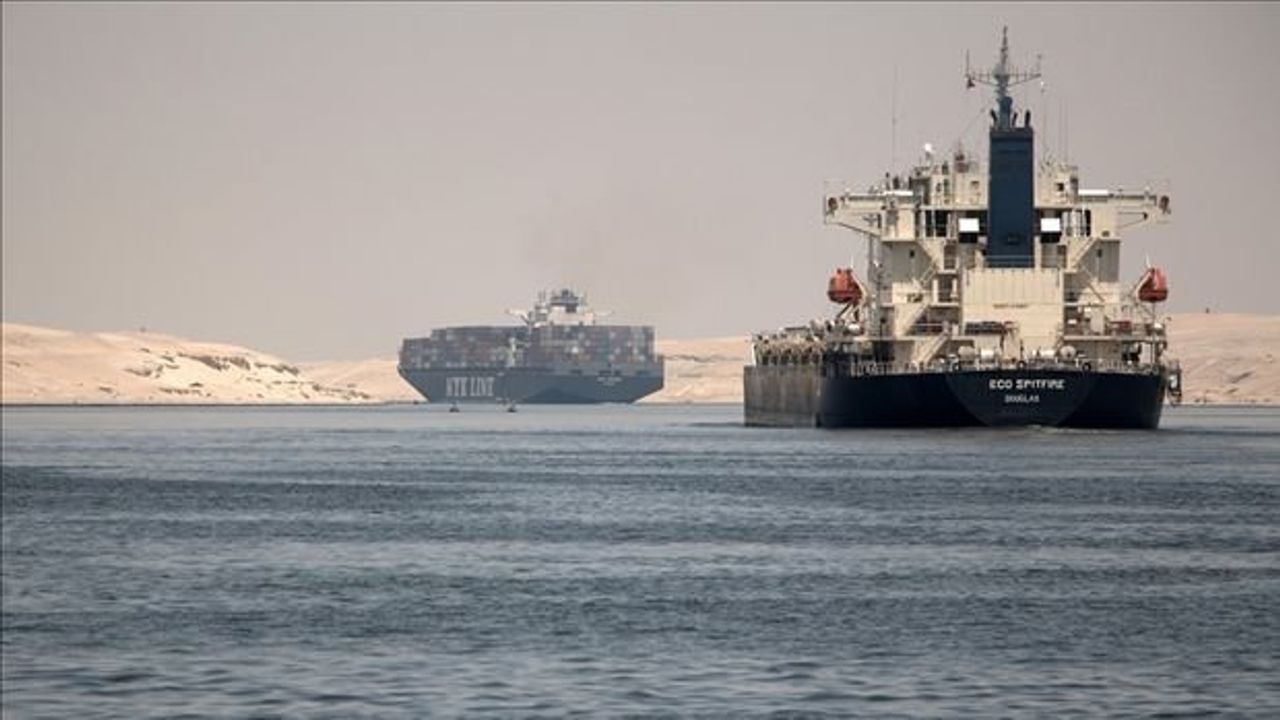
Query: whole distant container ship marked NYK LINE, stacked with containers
398,288,663,406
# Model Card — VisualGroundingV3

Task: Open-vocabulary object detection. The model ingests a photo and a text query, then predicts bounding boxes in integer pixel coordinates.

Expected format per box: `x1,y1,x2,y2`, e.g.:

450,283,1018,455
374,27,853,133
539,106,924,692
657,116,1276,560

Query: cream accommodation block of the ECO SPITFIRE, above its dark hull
826,146,1167,364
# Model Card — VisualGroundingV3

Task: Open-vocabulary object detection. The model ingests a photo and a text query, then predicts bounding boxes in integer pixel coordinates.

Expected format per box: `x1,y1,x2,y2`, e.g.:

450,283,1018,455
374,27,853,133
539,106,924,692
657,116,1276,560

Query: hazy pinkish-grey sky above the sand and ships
3,3,1280,360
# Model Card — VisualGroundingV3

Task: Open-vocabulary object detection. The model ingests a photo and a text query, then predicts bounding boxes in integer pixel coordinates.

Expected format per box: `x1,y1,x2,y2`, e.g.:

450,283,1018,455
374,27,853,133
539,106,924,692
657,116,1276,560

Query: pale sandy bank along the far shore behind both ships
3,313,1280,405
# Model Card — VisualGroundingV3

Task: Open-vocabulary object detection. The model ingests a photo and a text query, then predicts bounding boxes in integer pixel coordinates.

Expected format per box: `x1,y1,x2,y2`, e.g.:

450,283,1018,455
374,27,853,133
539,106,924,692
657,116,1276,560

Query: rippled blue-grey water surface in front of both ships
0,406,1280,719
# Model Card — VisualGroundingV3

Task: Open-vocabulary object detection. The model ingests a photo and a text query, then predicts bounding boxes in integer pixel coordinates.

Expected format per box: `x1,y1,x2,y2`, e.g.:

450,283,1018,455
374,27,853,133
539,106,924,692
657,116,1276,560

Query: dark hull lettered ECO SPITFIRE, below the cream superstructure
744,366,1167,429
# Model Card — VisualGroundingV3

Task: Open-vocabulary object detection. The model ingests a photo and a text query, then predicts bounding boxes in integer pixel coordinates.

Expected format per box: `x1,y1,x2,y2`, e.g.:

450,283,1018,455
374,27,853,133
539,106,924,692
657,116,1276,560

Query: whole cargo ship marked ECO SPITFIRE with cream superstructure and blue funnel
744,28,1181,428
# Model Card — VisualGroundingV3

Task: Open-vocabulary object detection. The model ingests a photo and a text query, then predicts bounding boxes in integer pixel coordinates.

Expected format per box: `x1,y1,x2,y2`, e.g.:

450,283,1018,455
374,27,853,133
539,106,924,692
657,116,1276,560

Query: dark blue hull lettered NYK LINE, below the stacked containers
401,368,662,405
